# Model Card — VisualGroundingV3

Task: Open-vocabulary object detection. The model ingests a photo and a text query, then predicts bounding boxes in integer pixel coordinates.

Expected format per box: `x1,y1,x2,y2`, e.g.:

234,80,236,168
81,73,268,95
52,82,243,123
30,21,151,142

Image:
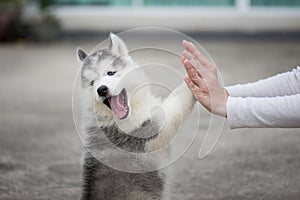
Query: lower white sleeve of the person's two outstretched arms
227,94,300,128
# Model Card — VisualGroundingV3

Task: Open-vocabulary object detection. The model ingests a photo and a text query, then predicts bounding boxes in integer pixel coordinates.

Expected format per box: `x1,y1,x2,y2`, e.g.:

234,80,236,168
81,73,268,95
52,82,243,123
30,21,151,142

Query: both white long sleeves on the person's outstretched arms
226,67,300,128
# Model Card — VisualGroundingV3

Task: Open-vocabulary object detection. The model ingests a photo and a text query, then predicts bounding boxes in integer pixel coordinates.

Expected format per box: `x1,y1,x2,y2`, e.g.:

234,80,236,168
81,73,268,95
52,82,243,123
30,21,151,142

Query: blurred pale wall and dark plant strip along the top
0,0,300,40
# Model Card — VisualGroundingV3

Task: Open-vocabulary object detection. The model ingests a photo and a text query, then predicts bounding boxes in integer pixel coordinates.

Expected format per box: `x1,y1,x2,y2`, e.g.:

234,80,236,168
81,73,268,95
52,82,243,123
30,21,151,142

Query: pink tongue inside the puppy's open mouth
110,92,127,119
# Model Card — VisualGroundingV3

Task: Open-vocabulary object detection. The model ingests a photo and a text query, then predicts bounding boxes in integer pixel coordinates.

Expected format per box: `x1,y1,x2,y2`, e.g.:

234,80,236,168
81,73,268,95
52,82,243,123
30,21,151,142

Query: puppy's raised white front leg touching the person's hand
147,82,196,151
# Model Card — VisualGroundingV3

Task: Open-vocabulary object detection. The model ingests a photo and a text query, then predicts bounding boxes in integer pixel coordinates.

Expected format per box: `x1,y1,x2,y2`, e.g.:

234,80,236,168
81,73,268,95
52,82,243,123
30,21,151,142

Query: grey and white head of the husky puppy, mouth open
77,33,135,119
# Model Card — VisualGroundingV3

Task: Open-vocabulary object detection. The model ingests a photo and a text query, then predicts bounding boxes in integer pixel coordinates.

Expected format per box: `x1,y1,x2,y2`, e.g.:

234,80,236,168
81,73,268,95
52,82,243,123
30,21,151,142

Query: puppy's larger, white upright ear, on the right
109,33,128,56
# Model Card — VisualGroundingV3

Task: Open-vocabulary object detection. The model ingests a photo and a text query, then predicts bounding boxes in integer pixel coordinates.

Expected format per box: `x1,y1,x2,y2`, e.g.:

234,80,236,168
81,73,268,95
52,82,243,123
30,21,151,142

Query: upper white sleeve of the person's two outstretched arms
226,67,300,97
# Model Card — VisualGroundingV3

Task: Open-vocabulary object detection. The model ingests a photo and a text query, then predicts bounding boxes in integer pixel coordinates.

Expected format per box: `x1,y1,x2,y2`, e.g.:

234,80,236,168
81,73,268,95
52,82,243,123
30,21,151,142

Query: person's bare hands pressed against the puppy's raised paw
182,40,228,117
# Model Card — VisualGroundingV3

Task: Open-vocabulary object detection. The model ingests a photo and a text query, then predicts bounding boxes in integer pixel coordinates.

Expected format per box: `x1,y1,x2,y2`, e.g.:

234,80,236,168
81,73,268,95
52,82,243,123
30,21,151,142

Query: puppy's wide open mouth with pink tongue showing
103,89,129,119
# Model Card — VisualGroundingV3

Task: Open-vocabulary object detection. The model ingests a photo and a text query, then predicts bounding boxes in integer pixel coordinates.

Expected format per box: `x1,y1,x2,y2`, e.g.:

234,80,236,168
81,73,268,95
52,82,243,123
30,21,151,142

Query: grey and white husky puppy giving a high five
77,33,195,200
